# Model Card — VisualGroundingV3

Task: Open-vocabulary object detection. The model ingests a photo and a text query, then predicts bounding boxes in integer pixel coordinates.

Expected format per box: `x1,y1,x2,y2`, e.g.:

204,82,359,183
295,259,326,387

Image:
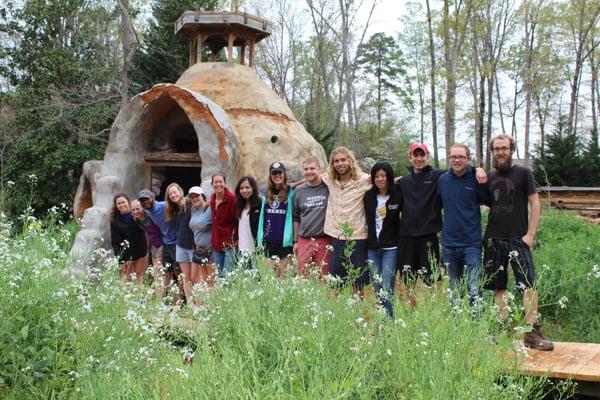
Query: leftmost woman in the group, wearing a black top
109,193,148,284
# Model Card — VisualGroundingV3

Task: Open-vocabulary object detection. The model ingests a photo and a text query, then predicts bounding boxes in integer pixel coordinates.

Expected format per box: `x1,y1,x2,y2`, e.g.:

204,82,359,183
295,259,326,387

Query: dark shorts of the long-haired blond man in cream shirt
329,239,369,289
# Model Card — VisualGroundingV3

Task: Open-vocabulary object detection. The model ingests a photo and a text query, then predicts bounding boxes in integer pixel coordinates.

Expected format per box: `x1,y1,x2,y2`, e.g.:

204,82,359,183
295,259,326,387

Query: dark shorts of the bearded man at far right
483,237,535,292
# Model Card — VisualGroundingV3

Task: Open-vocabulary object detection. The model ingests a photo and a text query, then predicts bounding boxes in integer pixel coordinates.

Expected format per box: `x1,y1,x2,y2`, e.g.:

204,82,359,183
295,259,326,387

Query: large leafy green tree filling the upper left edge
0,0,119,219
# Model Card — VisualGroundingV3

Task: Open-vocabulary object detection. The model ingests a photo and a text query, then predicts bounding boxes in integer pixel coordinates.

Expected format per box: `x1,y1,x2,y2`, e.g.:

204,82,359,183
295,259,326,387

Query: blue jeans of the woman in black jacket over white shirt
367,248,398,318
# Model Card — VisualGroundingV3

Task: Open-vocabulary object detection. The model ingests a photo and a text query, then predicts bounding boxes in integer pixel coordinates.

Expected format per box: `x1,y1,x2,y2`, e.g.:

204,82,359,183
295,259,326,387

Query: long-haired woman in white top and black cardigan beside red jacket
235,176,262,268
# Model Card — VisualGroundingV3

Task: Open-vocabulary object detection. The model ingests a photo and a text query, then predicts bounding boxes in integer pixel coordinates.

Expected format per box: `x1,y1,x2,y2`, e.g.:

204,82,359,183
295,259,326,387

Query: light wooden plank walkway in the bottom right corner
519,342,600,382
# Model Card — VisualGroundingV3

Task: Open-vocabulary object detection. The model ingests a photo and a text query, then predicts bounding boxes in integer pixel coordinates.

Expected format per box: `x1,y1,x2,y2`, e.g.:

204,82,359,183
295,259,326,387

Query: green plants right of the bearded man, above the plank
534,210,600,343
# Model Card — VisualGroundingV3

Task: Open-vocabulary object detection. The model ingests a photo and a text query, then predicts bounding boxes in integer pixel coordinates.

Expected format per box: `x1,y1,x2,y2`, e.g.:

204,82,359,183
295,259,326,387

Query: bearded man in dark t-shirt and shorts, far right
484,135,554,350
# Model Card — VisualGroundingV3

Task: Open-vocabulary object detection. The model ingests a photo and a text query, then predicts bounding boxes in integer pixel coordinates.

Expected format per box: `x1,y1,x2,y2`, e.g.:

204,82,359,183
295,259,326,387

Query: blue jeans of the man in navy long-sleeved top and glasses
442,246,481,306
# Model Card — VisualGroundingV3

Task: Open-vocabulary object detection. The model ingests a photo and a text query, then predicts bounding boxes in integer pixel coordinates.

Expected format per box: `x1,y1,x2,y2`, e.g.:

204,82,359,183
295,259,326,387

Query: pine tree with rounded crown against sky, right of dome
357,33,412,140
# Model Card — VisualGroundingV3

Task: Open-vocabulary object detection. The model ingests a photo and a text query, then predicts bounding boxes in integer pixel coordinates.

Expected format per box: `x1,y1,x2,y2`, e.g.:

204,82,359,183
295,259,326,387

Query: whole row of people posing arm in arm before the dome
111,135,553,350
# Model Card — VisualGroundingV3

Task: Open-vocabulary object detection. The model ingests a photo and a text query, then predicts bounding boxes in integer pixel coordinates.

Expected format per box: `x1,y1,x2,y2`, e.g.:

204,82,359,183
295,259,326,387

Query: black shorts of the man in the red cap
397,233,440,285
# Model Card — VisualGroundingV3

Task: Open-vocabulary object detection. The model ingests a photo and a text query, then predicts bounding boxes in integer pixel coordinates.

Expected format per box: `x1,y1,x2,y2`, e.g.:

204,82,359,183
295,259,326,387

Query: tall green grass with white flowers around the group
0,208,600,399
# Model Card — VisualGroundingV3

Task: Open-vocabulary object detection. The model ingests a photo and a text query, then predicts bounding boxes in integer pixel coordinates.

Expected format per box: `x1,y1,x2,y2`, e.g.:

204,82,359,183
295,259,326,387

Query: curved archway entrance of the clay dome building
136,84,238,193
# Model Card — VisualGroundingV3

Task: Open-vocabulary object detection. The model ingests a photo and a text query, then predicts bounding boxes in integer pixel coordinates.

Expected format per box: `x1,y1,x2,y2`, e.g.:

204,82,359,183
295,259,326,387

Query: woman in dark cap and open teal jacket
257,162,294,277
